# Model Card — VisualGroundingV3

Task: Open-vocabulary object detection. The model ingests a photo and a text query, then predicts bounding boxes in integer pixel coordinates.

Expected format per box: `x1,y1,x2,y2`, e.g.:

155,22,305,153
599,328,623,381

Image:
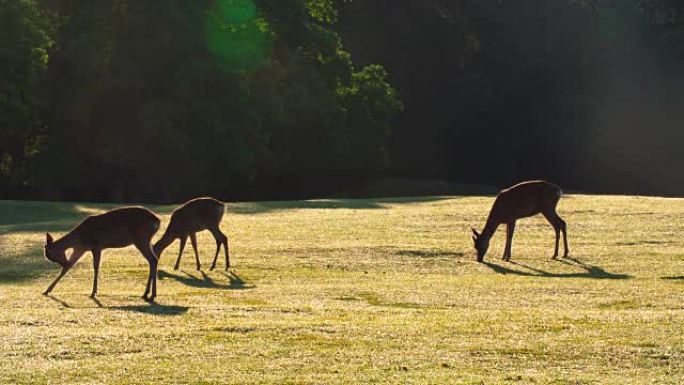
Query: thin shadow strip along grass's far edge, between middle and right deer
226,197,449,214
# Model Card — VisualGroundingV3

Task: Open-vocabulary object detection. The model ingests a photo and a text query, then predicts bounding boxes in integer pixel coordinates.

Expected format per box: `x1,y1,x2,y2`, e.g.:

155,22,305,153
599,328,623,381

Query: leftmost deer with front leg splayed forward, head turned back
43,207,160,302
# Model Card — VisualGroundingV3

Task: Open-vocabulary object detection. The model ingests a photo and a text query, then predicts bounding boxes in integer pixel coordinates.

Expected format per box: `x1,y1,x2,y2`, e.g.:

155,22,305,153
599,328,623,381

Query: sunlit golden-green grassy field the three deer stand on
0,195,684,384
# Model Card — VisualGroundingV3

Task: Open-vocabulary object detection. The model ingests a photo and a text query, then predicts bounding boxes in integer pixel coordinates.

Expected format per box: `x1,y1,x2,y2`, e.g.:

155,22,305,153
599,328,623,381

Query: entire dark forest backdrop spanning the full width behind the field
0,0,684,202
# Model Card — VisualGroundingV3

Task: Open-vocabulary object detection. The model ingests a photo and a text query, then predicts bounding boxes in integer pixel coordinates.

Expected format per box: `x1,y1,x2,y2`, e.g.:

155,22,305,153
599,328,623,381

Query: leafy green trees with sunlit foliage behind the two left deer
0,0,402,201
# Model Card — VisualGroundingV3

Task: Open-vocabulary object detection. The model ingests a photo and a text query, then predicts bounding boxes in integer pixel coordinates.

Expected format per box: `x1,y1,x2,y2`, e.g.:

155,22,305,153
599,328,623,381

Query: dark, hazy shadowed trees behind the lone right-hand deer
337,0,684,195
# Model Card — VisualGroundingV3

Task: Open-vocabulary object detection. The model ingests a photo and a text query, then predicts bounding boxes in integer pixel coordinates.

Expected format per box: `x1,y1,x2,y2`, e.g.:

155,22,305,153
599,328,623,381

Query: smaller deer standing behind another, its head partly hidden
154,198,230,270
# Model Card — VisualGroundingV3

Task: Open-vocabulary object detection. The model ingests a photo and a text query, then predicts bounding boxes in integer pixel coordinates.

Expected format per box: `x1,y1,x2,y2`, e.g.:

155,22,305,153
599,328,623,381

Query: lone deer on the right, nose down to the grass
471,180,568,262
